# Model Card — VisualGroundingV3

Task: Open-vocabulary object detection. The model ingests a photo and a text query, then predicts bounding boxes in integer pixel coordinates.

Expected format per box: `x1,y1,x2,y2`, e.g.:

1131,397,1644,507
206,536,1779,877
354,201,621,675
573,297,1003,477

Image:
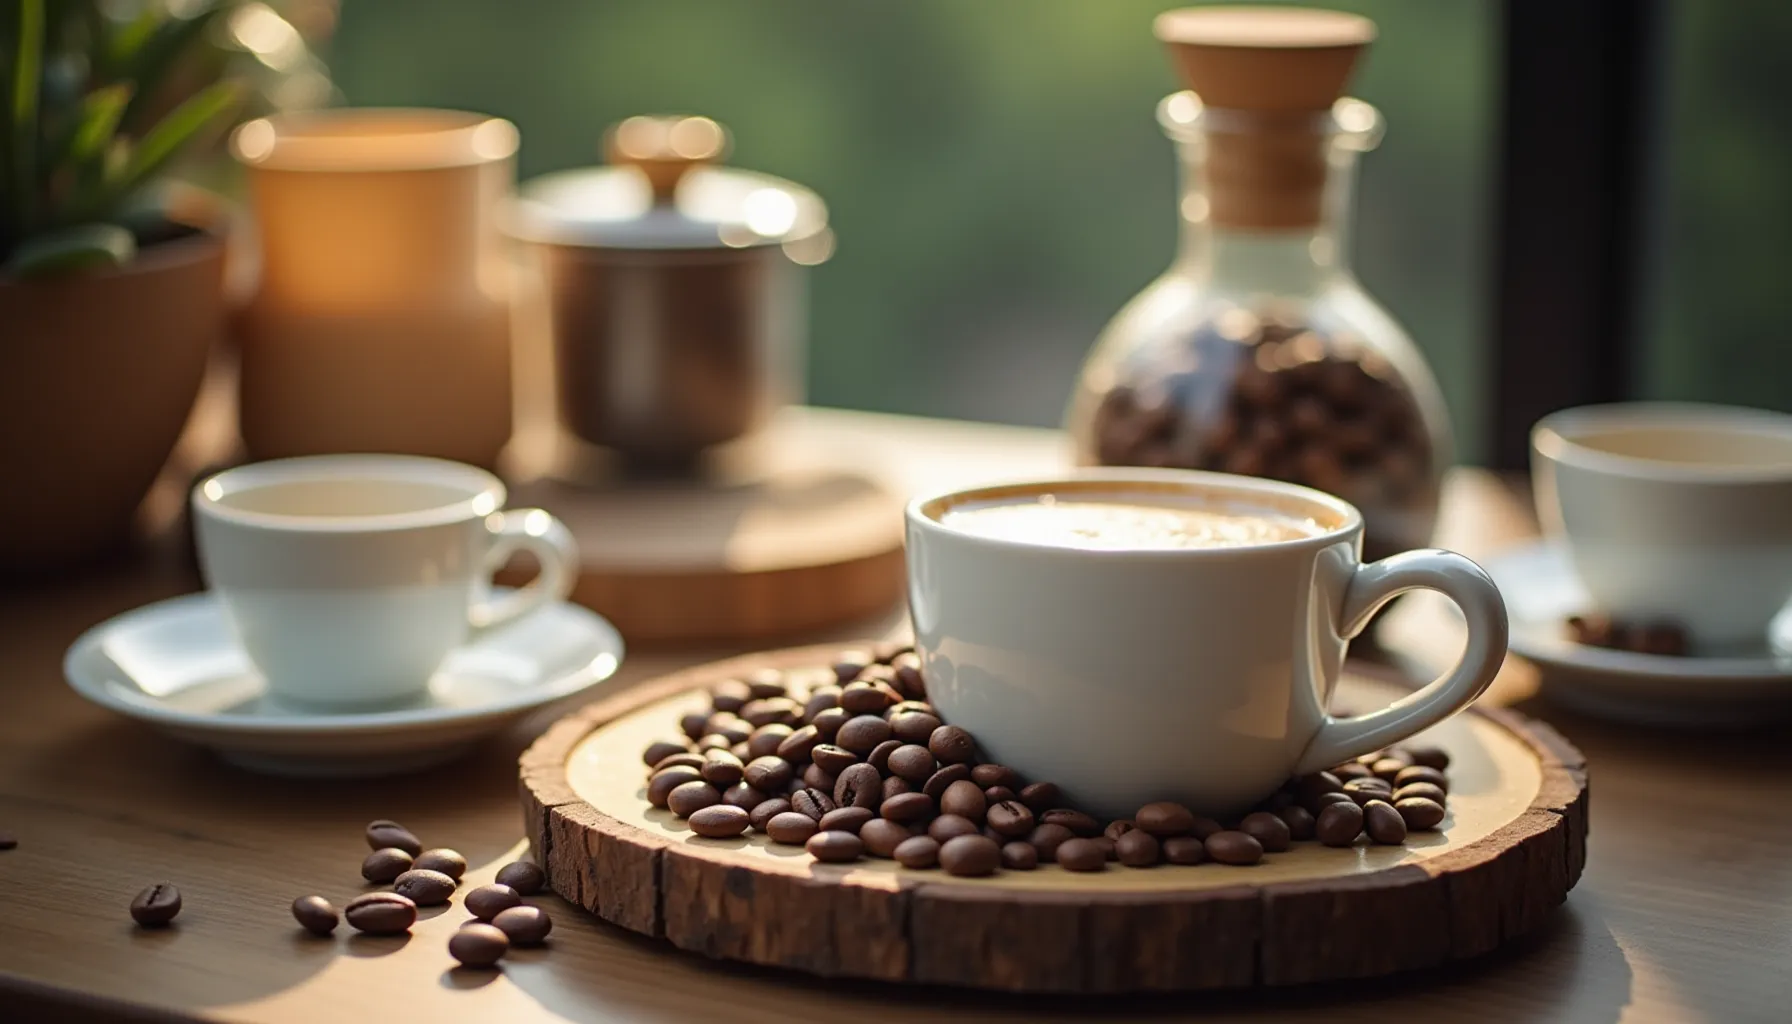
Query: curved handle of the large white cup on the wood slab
1294,549,1507,775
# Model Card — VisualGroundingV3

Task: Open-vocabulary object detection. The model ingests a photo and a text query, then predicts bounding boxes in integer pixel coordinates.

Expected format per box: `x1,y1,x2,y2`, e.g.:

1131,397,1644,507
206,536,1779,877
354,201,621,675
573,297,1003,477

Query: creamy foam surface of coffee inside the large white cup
939,495,1319,551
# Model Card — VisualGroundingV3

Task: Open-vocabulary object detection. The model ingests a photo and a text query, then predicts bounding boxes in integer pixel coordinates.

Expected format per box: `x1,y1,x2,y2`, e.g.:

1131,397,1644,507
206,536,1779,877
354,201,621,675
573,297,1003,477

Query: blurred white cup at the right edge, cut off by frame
1530,402,1792,647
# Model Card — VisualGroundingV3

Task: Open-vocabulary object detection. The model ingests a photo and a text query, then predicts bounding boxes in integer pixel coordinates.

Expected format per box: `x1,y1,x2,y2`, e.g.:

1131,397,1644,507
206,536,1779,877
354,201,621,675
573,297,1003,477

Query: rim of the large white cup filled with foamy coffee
905,466,1362,561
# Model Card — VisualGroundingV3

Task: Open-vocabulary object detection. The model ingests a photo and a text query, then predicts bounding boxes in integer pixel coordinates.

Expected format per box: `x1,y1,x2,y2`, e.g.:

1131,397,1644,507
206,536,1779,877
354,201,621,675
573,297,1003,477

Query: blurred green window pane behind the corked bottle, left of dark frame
332,0,1496,457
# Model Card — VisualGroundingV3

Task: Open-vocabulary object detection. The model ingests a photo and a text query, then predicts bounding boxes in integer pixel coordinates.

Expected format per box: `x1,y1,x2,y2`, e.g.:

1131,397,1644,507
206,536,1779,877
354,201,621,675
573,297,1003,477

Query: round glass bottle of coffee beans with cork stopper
1068,7,1452,560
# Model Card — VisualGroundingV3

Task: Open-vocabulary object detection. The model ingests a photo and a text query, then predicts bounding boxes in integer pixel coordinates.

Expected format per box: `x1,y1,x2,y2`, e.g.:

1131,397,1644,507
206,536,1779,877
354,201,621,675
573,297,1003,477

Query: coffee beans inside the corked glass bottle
1084,307,1437,560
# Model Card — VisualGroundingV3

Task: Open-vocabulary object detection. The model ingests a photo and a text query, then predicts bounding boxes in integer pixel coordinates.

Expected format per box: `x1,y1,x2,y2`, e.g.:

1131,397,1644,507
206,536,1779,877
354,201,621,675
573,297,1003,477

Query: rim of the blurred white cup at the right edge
1530,402,1792,484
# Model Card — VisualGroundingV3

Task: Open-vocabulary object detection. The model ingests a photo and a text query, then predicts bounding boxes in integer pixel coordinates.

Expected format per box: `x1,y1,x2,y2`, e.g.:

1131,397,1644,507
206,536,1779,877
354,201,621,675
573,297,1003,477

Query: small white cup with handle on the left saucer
192,456,579,710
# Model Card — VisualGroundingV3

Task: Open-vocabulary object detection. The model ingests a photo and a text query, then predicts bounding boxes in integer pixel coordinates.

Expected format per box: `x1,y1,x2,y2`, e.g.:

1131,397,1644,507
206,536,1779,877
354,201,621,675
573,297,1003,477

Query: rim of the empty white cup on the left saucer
192,456,507,534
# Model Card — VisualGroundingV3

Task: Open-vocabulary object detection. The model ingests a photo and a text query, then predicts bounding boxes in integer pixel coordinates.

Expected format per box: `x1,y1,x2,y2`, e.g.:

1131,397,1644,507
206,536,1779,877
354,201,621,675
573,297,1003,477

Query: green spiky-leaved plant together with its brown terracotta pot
0,0,265,574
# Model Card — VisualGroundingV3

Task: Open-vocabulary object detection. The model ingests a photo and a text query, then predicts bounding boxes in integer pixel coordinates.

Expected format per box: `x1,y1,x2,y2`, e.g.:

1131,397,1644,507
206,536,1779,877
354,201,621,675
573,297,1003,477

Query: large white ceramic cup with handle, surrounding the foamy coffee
907,470,1507,818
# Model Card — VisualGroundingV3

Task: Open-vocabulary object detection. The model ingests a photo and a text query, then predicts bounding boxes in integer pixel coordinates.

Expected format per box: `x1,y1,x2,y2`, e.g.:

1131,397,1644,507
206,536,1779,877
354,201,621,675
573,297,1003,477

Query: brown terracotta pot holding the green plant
0,233,226,576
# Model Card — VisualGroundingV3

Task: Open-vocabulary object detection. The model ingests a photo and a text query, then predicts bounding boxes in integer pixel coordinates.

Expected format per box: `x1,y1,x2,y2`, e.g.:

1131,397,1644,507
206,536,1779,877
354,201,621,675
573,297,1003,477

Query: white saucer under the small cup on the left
63,594,622,777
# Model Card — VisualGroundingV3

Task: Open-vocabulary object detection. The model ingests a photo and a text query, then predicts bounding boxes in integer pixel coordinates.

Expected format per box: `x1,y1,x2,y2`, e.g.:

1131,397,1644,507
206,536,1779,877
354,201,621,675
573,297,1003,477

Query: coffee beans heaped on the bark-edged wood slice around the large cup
642,646,1450,877
